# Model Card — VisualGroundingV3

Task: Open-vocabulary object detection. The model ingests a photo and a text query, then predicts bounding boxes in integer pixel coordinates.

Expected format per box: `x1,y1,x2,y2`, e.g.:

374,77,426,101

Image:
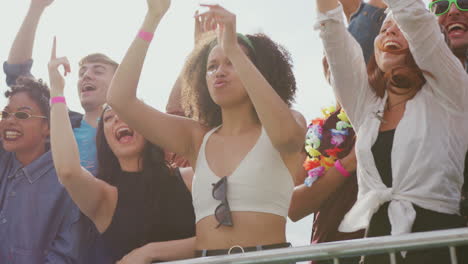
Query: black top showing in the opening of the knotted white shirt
371,129,395,188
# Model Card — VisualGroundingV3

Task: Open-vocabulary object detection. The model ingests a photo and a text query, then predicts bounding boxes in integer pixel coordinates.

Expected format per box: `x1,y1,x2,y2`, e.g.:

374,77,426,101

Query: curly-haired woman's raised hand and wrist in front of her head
196,4,239,55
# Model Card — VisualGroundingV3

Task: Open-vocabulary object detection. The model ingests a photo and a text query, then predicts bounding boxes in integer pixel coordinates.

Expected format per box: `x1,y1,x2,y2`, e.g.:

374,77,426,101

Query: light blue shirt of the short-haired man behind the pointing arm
73,119,98,176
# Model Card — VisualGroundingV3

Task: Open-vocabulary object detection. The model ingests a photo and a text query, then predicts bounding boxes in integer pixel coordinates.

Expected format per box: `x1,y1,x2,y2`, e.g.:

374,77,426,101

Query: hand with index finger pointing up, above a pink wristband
48,37,71,96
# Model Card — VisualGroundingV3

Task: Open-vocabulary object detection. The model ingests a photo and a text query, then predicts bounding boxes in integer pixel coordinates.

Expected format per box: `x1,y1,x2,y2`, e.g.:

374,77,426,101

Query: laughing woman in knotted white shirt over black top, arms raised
317,0,468,264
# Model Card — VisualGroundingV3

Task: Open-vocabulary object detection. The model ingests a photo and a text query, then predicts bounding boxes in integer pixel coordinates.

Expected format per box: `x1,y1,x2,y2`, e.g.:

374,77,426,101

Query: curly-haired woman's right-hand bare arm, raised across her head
196,5,306,153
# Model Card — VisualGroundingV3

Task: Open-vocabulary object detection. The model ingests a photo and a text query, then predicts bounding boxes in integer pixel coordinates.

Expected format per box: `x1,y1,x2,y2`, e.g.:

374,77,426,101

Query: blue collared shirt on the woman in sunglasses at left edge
0,144,84,264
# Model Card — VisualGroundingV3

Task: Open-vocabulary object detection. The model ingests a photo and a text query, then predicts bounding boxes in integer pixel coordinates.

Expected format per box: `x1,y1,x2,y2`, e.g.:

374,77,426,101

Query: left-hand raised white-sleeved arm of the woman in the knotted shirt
315,0,375,131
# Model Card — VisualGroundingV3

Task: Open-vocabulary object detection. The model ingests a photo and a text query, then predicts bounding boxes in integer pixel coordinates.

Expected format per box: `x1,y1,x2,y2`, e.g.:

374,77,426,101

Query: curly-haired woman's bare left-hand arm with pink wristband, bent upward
107,0,204,163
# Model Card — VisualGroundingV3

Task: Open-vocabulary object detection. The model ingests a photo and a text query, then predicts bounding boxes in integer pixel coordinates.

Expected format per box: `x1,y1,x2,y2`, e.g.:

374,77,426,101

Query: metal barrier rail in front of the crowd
160,228,468,264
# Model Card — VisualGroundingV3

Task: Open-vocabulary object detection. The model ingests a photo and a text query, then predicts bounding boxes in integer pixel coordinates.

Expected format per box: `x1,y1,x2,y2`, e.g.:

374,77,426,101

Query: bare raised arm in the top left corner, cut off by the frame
8,0,54,64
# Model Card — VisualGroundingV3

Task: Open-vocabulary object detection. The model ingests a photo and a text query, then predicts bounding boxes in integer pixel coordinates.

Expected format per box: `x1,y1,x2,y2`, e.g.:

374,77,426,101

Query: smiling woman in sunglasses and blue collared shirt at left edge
0,78,84,264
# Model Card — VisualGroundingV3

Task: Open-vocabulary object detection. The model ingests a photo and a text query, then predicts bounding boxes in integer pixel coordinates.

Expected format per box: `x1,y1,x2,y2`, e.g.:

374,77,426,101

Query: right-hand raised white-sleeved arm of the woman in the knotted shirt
386,0,468,111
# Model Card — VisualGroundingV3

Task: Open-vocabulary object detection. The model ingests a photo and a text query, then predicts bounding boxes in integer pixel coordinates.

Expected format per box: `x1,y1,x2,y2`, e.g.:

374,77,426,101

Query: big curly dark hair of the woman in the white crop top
182,34,296,127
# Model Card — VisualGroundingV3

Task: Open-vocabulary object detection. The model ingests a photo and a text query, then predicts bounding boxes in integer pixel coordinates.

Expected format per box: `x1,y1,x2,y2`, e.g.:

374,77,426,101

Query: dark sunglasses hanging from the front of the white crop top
212,177,233,228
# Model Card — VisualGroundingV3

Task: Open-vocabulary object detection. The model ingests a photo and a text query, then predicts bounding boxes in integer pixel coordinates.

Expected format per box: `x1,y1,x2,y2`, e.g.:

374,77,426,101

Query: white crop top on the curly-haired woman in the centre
192,127,294,222
